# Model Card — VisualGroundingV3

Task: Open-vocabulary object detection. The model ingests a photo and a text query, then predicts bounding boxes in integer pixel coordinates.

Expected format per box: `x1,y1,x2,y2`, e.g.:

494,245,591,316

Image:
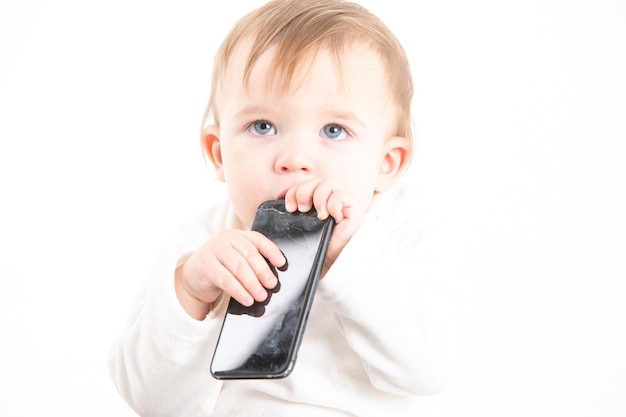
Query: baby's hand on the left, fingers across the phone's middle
176,229,286,319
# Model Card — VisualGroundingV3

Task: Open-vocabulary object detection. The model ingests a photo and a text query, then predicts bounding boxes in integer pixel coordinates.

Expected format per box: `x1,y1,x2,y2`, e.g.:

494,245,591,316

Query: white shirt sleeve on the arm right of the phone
319,184,470,395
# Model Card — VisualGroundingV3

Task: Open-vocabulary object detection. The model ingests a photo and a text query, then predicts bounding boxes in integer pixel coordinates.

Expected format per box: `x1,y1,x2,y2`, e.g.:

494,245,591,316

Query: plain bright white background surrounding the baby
0,0,626,417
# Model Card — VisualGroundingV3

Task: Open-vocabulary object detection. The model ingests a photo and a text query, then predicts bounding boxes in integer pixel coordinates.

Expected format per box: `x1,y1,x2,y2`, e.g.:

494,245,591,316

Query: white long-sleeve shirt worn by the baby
109,186,468,417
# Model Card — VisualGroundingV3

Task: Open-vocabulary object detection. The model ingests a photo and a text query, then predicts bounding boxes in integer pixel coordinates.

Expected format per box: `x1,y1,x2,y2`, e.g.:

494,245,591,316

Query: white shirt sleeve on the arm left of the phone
108,204,232,416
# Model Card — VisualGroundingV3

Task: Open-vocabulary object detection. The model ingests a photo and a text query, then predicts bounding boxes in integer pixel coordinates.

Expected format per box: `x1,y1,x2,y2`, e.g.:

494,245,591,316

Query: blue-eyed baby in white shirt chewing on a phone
109,0,466,417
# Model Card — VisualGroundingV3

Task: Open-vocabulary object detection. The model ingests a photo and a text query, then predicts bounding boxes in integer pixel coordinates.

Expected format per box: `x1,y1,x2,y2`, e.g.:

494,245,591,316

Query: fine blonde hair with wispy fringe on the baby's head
202,0,413,155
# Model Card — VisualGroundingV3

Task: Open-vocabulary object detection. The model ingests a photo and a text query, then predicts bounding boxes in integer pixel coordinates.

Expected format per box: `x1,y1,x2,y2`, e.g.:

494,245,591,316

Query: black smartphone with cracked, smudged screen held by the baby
211,200,334,379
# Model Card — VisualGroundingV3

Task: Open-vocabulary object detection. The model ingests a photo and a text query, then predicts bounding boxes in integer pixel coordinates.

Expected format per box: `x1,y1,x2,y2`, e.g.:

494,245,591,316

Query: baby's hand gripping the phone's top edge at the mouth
285,179,366,268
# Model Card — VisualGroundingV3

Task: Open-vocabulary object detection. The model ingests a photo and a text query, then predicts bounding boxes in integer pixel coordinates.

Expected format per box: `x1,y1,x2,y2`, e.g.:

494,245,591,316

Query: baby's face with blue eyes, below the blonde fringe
208,45,395,227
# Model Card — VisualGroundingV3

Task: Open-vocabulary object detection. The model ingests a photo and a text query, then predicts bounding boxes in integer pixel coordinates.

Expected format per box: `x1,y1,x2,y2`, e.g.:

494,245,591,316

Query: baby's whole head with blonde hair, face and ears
202,0,413,228
